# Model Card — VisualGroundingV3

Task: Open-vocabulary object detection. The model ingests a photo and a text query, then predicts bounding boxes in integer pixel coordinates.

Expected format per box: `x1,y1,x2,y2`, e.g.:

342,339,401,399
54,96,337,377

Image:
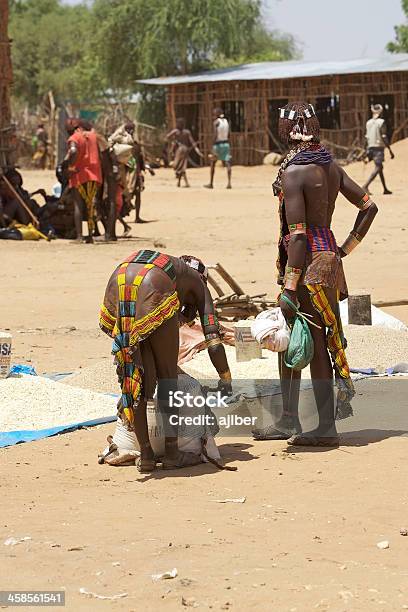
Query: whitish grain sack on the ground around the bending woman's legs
102,373,221,465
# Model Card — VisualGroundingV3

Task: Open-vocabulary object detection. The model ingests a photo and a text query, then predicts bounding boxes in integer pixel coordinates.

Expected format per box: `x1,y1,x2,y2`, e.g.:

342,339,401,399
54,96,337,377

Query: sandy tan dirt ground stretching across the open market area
0,149,408,612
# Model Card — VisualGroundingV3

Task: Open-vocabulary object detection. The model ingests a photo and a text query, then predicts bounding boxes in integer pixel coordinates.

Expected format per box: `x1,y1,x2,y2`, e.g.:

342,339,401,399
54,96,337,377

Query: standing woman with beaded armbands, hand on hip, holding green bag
254,102,377,446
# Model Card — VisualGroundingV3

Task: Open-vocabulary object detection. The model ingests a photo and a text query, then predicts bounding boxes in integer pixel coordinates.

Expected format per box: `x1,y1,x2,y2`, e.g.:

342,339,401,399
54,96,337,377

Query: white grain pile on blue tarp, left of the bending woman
0,376,116,431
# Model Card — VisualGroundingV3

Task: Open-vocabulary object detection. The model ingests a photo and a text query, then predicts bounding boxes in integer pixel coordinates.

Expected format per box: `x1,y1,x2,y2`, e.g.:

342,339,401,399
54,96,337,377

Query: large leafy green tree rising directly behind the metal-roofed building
94,0,296,86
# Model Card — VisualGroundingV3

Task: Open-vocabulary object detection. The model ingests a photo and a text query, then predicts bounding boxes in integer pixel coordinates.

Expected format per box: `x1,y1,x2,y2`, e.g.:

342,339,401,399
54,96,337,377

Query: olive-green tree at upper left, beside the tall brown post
10,0,103,105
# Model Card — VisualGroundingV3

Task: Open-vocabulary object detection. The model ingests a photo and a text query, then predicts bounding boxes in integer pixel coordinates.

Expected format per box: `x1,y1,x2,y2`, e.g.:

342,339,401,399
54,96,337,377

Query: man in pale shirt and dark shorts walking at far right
364,104,394,195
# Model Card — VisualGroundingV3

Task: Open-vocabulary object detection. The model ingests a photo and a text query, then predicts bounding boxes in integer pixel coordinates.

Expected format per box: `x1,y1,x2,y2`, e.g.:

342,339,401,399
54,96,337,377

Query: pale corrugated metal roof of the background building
138,53,408,86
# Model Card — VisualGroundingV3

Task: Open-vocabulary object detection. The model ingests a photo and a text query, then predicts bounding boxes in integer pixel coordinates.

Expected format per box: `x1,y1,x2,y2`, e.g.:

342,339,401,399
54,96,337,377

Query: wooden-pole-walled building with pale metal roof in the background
141,54,408,165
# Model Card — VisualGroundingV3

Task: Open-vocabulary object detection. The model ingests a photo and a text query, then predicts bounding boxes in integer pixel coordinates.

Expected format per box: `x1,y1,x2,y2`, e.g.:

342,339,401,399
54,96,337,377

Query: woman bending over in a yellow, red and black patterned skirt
100,250,231,472
